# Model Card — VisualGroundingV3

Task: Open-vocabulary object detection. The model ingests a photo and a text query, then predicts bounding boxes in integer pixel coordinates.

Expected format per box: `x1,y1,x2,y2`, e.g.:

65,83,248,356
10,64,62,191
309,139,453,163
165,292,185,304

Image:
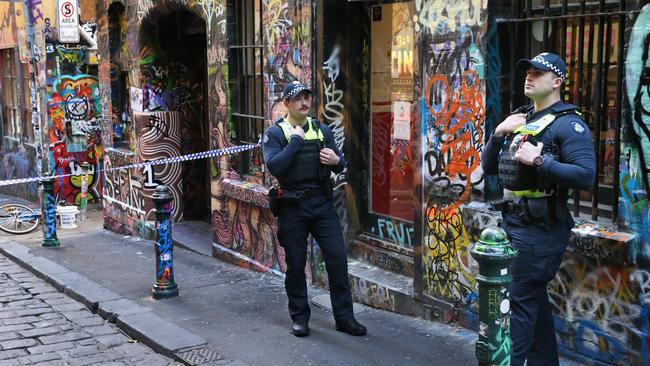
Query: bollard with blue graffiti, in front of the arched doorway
151,185,178,299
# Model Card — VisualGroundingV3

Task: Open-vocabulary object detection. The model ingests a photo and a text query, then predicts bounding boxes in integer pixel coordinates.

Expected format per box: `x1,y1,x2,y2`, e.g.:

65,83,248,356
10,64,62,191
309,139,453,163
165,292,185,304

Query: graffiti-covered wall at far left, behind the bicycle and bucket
0,0,103,204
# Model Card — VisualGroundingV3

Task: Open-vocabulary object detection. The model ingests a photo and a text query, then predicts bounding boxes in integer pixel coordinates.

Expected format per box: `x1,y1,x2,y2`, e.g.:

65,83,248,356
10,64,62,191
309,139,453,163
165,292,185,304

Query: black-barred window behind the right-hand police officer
487,0,625,222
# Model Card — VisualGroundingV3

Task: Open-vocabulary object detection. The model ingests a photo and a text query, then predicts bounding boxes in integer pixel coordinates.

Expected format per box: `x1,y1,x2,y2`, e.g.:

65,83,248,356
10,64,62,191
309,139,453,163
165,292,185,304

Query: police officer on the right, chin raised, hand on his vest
481,53,596,366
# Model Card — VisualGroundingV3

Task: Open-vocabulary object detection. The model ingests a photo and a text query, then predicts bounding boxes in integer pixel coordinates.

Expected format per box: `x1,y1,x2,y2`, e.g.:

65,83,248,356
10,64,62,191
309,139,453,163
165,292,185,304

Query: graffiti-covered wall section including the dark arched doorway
98,1,215,233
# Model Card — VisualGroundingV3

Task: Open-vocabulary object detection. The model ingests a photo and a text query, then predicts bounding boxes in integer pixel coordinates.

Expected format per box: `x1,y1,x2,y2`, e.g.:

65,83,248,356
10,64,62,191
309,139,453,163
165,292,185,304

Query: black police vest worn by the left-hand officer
277,117,332,189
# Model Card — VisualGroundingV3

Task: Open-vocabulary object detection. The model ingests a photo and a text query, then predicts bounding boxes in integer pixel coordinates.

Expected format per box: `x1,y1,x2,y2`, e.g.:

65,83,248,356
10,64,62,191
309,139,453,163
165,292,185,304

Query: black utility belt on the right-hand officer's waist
490,195,569,227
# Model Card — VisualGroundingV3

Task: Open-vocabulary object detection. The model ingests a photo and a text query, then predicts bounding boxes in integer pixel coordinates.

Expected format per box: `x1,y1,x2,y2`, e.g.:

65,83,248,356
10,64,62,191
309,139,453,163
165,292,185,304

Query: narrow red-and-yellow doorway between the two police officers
366,1,418,255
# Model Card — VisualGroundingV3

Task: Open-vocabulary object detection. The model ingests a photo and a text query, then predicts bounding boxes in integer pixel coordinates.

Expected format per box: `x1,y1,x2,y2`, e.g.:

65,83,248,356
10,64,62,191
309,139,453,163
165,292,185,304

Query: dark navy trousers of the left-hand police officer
278,195,354,321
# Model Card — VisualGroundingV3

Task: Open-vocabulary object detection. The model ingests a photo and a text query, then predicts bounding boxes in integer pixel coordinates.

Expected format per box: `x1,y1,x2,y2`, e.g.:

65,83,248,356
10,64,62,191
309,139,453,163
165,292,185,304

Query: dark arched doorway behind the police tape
139,5,211,222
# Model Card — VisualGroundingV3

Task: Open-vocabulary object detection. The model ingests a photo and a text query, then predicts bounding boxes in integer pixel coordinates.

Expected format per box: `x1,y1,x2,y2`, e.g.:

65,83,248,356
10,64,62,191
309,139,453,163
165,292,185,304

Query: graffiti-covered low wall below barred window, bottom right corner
549,255,650,364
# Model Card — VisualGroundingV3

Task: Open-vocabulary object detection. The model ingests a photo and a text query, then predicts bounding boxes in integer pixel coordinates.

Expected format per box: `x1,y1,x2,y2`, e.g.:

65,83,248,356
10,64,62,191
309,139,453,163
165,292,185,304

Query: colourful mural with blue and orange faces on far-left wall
46,32,104,204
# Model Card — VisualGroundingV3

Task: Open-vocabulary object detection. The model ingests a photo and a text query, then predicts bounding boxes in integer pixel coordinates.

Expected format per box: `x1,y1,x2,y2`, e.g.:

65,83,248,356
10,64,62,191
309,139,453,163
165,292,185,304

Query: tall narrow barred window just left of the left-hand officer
229,0,265,179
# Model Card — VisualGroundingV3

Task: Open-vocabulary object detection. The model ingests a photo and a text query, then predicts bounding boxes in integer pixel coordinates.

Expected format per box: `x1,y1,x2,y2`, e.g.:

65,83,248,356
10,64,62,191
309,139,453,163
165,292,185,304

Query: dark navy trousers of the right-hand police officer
508,243,562,366
